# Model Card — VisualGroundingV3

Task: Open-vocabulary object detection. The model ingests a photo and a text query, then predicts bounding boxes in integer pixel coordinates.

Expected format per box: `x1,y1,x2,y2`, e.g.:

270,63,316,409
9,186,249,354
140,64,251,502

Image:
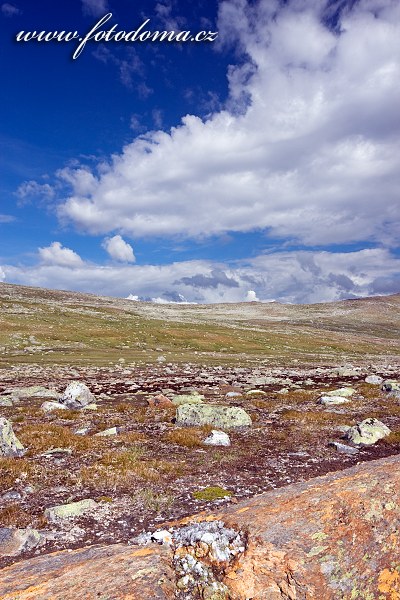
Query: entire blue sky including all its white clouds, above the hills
0,0,400,302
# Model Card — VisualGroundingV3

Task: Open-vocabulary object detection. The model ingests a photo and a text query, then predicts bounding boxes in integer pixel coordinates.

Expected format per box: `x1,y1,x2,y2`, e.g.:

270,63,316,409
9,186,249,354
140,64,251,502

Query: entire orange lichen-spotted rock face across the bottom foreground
0,456,400,600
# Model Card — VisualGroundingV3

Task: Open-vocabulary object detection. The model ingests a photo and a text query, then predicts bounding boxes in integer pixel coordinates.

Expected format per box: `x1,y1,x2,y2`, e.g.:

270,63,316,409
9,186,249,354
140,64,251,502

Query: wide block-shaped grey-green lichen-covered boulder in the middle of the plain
176,404,251,429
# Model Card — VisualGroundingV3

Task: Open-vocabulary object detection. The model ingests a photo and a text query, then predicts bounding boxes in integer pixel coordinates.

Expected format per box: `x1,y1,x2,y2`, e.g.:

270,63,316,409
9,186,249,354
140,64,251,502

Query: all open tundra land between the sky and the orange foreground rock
0,284,400,584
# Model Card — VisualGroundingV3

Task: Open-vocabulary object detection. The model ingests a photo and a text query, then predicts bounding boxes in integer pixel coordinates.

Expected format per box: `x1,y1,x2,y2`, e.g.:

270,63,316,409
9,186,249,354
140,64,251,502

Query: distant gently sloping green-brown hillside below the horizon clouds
0,283,400,366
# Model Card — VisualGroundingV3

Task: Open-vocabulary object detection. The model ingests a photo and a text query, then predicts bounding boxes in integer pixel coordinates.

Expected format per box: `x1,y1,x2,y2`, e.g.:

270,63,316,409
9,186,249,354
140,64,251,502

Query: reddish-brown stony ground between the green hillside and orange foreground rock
0,364,400,566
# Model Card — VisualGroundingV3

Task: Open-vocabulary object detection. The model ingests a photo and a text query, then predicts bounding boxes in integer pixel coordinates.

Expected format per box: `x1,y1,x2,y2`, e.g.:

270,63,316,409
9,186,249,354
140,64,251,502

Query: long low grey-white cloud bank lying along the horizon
0,247,400,303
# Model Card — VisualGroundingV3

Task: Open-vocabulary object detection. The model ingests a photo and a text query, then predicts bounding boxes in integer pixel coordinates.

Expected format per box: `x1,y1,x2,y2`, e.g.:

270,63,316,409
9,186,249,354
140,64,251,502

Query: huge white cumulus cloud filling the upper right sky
58,0,400,246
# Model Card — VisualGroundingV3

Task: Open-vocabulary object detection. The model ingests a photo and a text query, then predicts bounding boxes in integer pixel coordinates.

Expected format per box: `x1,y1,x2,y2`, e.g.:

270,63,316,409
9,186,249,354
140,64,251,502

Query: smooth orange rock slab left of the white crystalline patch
0,544,175,600
